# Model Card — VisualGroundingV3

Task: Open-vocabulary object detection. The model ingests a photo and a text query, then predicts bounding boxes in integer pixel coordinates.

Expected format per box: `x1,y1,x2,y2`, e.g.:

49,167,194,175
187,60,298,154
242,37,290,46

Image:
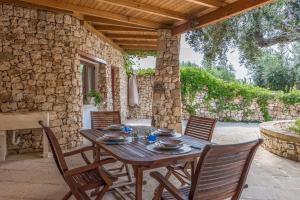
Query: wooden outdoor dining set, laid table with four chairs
39,111,262,200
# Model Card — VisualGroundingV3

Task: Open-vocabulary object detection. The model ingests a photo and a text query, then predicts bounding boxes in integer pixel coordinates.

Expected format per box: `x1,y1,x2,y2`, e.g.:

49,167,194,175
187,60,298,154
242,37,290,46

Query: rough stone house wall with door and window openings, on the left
0,3,127,151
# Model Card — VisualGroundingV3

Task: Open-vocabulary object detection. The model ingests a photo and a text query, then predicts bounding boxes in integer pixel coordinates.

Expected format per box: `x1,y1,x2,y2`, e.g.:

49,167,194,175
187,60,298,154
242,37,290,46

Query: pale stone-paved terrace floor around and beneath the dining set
0,120,300,200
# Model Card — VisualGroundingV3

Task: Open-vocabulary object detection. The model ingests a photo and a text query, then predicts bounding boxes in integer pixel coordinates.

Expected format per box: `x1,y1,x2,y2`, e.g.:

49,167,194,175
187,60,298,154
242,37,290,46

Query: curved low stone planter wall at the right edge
260,120,300,162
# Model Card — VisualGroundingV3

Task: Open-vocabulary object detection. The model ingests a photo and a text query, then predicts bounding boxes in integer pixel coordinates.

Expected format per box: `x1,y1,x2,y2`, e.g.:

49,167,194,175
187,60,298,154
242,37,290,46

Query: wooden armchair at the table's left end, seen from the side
39,121,115,200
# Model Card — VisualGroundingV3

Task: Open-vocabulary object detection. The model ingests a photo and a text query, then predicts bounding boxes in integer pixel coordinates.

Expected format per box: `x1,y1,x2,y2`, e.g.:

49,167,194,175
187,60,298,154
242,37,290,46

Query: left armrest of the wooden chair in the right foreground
150,172,188,200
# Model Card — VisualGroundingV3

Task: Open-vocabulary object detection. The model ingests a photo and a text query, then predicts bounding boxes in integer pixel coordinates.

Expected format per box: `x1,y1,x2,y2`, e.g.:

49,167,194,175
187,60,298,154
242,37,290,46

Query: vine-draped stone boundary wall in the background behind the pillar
129,76,300,121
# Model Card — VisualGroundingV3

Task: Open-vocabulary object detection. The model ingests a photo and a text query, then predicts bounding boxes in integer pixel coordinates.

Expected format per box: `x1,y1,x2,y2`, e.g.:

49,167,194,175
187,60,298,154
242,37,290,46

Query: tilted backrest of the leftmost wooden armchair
39,121,68,176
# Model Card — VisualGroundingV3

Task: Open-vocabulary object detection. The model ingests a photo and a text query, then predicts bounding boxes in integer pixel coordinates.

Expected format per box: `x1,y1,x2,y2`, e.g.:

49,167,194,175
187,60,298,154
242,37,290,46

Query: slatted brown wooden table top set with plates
80,129,211,166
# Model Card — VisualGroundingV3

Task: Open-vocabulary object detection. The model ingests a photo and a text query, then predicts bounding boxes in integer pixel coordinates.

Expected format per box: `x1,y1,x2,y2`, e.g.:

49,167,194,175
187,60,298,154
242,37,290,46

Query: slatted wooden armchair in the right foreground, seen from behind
150,139,263,200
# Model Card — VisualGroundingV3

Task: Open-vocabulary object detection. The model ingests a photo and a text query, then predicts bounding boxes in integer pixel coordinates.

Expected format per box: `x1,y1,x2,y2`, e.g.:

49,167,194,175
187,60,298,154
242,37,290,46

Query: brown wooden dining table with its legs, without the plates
80,129,210,200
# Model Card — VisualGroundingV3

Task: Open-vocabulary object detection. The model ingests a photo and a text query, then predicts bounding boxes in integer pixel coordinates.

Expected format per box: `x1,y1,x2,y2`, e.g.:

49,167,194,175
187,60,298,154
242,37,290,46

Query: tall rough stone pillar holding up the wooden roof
152,29,182,132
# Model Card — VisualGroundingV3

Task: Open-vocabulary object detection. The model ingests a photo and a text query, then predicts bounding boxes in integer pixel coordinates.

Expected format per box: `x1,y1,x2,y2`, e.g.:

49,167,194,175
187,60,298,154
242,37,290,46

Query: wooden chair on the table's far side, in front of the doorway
91,111,132,182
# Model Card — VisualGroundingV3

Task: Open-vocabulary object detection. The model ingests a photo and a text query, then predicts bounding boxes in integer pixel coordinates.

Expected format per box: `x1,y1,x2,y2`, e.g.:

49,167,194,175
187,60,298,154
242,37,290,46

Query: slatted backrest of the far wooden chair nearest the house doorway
91,111,121,129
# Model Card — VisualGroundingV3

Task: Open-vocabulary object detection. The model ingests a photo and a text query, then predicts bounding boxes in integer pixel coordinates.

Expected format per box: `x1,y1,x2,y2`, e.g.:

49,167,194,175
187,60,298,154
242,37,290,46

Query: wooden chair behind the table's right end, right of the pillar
166,116,217,185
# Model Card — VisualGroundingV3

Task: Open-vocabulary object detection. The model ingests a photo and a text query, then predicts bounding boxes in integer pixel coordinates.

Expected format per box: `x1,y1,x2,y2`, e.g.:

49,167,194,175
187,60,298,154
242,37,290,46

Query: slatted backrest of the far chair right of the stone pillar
184,116,217,141
